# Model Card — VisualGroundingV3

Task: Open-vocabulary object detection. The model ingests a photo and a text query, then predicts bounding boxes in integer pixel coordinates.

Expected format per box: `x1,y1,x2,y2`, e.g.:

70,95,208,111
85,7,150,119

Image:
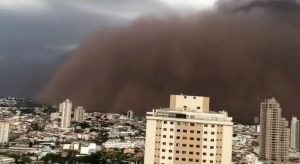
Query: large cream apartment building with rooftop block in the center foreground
144,95,233,164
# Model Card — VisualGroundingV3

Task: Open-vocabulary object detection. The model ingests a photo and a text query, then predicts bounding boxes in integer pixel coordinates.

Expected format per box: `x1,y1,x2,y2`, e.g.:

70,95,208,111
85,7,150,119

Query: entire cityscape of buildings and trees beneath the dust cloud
0,95,300,164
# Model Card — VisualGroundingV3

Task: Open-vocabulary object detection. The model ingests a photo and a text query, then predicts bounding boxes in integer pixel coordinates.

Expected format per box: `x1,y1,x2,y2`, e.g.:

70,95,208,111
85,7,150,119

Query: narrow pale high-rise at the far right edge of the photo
291,117,300,151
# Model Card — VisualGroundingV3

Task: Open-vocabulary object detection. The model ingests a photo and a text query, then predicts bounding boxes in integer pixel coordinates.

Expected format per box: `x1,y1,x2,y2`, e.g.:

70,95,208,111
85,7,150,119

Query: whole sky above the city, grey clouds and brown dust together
0,0,300,122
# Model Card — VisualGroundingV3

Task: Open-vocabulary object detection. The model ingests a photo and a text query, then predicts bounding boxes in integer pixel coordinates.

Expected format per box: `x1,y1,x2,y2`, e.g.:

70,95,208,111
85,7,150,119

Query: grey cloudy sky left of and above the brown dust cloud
0,0,216,98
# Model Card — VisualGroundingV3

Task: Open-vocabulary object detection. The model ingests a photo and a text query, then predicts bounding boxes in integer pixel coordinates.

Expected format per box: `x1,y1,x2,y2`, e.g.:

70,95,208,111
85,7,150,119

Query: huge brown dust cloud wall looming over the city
37,0,300,122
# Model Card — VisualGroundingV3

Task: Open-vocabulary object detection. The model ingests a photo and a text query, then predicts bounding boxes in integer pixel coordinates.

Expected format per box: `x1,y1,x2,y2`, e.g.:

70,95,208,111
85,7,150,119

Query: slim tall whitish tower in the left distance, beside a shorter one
59,99,72,128
